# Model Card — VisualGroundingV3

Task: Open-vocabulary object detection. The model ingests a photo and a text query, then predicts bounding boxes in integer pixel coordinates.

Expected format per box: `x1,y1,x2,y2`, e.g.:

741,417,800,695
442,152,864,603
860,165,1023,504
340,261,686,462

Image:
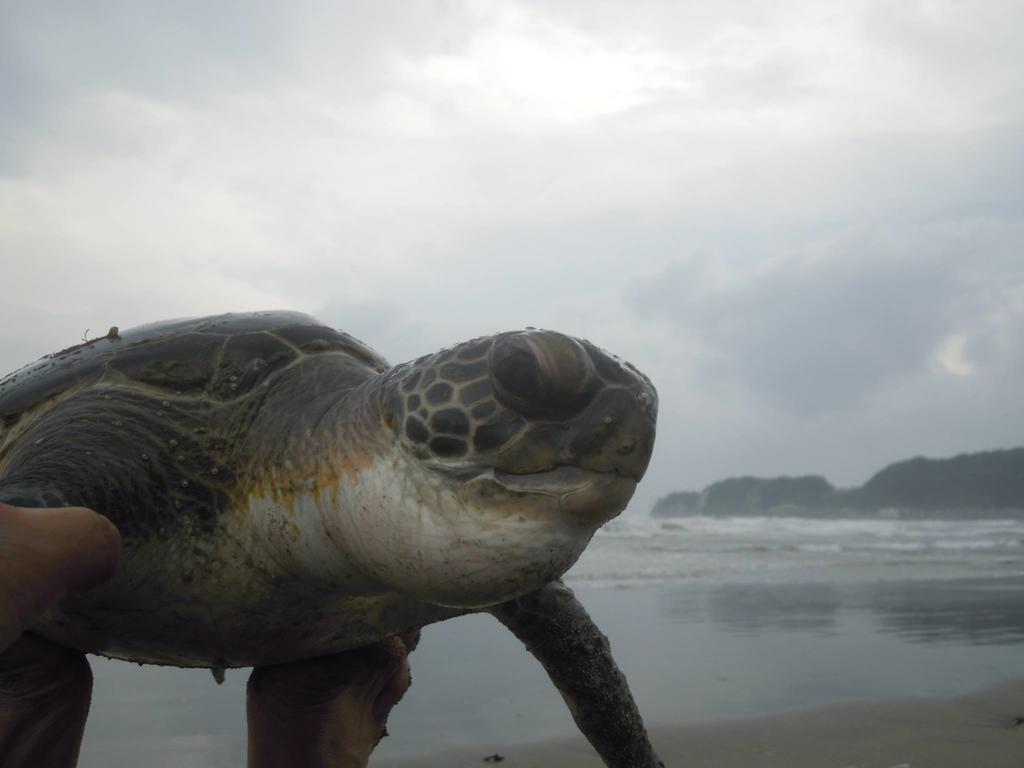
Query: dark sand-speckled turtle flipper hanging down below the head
488,581,665,768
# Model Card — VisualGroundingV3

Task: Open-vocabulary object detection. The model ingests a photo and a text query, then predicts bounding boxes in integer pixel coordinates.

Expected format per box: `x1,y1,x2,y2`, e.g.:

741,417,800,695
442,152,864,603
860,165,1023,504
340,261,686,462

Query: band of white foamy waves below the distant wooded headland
567,517,1024,587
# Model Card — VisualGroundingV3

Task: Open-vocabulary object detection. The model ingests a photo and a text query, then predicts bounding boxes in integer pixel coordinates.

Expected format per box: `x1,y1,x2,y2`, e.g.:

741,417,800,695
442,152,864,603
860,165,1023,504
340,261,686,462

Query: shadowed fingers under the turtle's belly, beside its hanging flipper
246,632,419,768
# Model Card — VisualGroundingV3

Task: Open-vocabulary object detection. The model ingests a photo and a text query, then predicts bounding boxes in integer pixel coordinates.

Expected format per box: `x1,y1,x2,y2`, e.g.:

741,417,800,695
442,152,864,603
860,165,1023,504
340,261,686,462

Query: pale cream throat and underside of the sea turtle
36,461,604,668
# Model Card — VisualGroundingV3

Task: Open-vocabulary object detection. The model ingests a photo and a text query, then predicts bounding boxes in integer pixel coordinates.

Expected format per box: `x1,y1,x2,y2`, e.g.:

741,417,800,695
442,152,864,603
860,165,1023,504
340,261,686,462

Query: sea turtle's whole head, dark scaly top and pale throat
331,330,657,607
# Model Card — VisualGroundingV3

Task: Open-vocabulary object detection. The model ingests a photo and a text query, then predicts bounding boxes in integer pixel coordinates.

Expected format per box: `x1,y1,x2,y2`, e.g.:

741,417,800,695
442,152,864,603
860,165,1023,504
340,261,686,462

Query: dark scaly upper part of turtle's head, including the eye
387,330,657,495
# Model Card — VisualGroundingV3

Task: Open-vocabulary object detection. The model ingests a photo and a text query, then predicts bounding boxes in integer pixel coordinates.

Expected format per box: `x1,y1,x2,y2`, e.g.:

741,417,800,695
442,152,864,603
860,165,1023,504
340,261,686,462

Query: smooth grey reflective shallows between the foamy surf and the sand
80,577,1024,768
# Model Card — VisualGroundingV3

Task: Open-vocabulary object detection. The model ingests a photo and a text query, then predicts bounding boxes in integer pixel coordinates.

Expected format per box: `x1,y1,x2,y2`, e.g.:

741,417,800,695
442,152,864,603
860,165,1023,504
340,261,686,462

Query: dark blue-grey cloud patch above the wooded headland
630,221,1024,417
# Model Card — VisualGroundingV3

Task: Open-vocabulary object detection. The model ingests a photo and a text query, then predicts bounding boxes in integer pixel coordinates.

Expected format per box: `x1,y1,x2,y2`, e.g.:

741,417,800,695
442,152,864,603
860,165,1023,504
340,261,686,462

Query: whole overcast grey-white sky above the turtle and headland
0,0,1024,518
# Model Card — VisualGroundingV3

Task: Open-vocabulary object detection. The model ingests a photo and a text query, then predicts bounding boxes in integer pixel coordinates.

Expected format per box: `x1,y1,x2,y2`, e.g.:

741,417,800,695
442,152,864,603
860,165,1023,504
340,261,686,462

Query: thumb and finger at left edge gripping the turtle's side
0,503,121,768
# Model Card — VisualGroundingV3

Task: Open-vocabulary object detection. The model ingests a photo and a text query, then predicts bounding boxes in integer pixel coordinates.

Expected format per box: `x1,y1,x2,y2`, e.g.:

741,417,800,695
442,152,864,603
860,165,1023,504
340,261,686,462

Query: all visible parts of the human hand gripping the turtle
0,503,419,768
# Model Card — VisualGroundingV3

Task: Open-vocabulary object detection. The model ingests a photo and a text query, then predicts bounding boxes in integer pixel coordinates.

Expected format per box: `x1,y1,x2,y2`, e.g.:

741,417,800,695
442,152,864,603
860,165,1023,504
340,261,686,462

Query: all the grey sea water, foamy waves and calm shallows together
80,517,1024,768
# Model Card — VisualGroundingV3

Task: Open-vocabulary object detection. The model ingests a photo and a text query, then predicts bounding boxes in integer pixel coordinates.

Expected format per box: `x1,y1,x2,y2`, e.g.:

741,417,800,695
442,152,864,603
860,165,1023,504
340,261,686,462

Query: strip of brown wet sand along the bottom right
372,684,1024,768
